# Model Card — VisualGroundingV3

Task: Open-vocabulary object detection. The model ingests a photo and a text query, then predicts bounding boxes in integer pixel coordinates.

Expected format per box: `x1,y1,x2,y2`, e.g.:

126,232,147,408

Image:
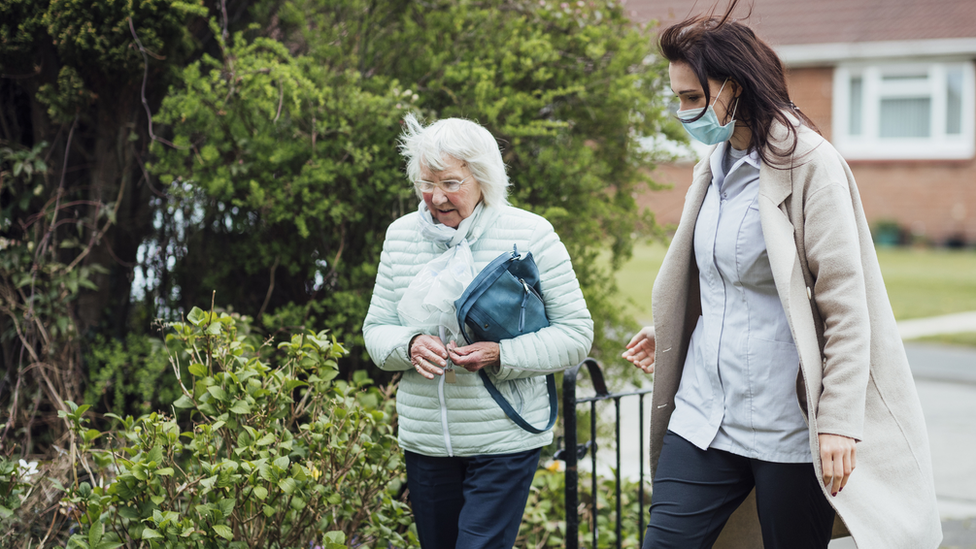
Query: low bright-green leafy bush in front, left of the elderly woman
59,308,415,549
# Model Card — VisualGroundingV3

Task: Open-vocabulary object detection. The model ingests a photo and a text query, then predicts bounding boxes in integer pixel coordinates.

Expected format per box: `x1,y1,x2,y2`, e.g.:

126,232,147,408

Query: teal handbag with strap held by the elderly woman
454,245,558,434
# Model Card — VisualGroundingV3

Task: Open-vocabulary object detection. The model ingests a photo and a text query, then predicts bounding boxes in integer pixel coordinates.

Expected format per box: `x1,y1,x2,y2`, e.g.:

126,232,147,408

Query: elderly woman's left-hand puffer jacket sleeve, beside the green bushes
363,227,422,371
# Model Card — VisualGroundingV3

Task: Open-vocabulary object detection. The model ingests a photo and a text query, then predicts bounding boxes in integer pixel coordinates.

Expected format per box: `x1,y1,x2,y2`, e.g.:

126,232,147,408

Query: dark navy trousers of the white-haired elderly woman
405,448,542,549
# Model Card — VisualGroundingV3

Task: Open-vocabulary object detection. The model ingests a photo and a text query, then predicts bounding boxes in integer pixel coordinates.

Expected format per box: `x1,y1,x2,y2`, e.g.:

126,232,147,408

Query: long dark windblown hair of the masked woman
658,0,820,166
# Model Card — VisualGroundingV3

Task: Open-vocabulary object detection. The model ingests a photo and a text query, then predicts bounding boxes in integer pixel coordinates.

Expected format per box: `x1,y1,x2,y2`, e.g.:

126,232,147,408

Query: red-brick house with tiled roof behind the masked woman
624,0,976,245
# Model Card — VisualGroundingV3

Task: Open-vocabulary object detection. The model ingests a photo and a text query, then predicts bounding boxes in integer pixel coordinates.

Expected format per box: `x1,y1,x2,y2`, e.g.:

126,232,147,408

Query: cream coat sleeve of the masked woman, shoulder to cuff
804,149,871,440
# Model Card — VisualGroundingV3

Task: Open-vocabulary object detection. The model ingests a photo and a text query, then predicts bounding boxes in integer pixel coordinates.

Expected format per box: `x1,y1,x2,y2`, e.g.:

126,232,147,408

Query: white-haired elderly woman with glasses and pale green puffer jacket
363,115,593,549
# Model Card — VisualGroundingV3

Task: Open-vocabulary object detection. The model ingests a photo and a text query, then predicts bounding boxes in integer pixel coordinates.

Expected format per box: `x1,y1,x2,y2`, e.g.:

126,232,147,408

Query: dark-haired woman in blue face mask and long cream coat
624,0,942,549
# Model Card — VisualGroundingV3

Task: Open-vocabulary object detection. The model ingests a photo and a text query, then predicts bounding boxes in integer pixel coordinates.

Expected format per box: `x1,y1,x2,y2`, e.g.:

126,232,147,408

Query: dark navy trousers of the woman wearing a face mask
643,431,834,549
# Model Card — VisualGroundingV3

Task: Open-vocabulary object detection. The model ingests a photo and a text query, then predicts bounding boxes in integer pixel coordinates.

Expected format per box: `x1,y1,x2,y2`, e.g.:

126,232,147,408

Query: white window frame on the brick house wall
831,58,976,160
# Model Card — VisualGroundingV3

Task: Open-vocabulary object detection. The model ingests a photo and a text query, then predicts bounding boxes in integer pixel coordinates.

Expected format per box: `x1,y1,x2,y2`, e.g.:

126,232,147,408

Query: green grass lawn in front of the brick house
617,243,976,330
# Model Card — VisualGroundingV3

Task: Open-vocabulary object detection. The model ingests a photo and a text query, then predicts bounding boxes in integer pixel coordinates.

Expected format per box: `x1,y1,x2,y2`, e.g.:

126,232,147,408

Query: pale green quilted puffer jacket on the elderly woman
363,206,593,456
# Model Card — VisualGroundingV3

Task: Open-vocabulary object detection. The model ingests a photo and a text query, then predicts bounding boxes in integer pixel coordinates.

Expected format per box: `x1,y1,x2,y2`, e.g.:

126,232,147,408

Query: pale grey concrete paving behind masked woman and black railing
580,312,976,549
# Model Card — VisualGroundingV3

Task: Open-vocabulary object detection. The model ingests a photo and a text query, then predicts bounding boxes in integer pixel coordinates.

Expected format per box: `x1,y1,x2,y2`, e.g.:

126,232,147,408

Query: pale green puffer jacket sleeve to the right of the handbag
489,216,593,380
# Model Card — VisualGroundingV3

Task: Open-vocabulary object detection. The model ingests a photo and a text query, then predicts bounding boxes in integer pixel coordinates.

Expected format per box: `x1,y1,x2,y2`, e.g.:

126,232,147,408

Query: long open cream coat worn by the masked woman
651,121,942,549
